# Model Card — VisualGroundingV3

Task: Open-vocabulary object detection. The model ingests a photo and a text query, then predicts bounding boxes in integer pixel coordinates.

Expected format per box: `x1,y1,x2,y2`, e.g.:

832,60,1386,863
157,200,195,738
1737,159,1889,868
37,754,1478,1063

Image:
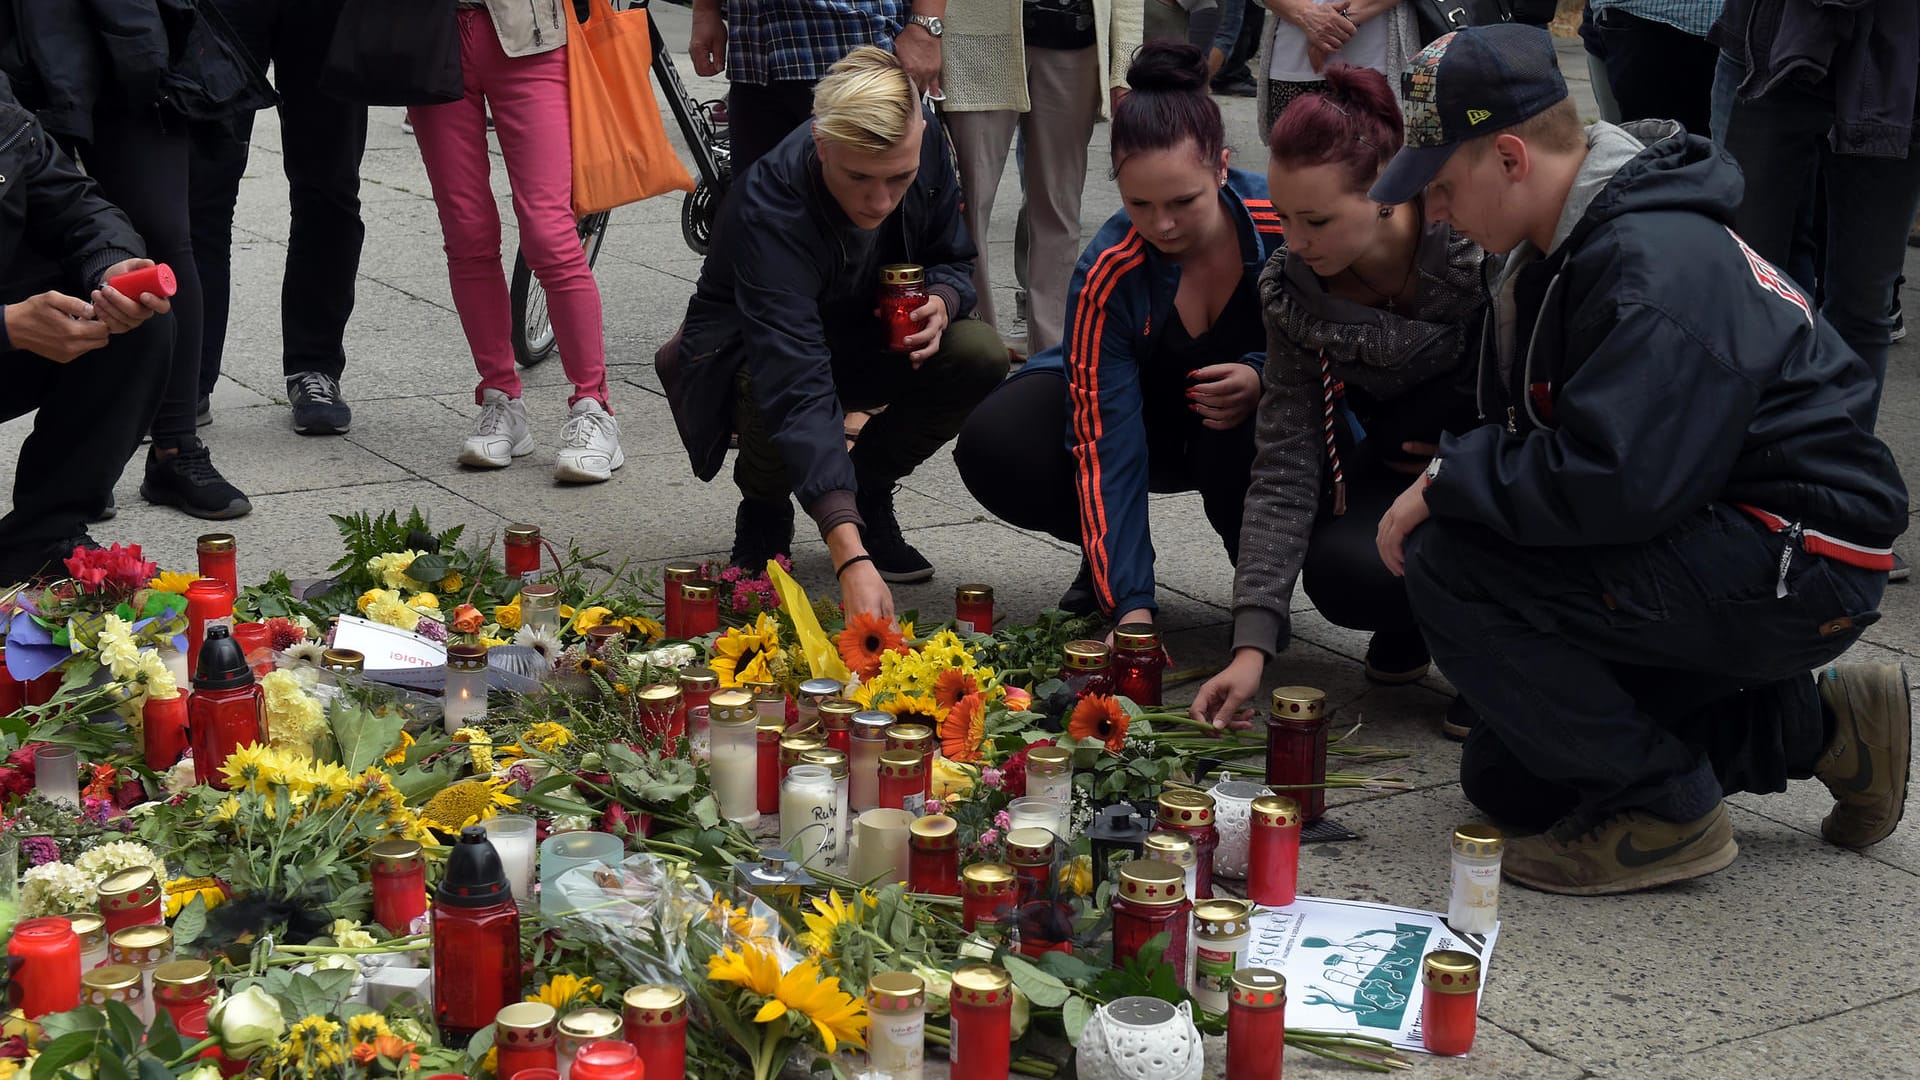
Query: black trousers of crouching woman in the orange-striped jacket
954,371,1254,561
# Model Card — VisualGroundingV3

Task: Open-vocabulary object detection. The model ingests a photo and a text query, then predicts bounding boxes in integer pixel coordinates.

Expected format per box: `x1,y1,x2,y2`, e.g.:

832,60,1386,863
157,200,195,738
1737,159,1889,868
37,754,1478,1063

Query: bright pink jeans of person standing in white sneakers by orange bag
407,8,607,405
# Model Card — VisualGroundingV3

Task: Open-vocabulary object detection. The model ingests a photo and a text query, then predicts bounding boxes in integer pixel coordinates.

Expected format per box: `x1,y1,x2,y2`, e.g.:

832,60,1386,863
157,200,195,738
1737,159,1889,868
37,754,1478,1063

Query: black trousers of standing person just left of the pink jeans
190,0,367,382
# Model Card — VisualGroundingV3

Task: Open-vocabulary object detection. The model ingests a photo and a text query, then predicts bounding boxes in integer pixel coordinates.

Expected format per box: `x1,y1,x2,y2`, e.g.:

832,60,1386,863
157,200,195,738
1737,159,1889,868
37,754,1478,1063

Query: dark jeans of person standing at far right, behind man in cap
1713,54,1920,426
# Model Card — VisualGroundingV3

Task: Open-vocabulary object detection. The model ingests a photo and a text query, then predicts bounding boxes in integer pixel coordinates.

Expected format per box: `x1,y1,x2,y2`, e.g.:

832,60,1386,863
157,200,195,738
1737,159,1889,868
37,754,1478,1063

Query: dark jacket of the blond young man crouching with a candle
659,105,975,523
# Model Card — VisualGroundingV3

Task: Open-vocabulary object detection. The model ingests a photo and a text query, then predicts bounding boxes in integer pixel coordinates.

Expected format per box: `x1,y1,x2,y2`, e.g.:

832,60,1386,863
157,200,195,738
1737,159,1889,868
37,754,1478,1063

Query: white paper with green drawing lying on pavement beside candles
1242,896,1500,1051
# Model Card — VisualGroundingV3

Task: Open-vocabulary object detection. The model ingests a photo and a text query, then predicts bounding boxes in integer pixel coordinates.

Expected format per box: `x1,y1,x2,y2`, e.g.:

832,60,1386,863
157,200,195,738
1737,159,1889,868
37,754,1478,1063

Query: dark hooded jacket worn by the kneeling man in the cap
1427,121,1907,548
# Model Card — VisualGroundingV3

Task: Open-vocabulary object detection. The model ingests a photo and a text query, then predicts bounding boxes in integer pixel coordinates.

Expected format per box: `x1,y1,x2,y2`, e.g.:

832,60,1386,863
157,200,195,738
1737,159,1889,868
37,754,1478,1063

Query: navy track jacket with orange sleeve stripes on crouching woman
1014,169,1281,615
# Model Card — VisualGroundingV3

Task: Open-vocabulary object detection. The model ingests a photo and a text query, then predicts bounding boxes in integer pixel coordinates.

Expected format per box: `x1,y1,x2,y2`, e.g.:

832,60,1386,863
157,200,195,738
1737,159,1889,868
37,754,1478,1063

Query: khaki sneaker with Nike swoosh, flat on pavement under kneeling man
1500,803,1740,896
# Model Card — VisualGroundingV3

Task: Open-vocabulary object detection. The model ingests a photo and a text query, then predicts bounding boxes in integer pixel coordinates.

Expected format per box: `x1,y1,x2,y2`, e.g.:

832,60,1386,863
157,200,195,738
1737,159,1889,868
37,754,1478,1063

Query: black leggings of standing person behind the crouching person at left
71,110,204,444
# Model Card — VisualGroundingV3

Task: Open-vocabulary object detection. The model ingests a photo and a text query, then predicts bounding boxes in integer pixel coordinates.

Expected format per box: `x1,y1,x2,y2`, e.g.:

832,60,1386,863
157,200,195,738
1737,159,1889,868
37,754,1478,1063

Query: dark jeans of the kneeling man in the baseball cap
1407,503,1887,828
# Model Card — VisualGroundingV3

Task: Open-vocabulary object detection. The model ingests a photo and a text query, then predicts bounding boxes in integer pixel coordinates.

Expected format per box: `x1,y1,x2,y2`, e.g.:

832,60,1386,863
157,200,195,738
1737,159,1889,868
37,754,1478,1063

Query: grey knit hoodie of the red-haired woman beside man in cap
1233,225,1486,653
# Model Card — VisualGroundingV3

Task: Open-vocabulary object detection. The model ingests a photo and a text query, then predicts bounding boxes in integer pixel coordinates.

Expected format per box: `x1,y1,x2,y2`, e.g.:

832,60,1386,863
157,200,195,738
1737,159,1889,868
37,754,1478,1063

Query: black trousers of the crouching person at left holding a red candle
0,315,173,564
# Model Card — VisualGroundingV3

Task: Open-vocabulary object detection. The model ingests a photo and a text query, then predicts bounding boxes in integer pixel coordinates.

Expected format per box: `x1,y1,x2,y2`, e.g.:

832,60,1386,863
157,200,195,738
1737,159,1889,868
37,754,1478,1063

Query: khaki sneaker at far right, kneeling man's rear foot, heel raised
1812,663,1912,847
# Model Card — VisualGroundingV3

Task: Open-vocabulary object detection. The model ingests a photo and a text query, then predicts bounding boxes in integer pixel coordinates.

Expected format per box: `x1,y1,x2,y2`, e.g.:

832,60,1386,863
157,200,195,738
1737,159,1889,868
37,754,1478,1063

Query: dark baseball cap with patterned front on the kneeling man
1371,23,1567,206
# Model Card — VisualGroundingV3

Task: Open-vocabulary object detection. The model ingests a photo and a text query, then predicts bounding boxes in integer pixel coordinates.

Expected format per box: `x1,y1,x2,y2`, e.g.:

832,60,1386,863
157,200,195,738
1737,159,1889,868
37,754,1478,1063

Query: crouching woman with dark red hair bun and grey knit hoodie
1194,63,1486,734
